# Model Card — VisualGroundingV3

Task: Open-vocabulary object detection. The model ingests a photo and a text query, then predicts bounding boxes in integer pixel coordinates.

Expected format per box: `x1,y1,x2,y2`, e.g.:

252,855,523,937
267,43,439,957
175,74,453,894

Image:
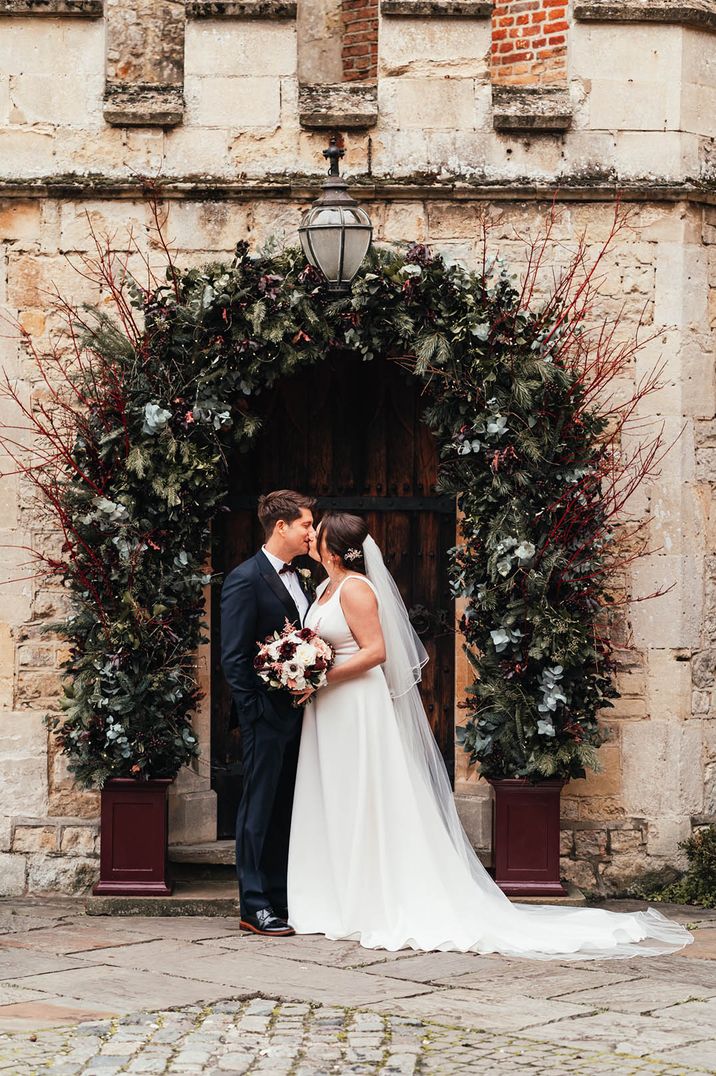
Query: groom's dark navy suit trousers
236,713,301,915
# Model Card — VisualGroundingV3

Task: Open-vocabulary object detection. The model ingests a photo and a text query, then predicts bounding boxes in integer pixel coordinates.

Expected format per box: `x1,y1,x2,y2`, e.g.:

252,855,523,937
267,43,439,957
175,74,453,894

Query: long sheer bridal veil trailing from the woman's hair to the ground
363,536,693,960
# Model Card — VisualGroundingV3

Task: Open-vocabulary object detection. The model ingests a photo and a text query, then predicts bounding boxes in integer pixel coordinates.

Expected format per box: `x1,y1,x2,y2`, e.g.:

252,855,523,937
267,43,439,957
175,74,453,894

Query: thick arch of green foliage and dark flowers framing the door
40,243,616,784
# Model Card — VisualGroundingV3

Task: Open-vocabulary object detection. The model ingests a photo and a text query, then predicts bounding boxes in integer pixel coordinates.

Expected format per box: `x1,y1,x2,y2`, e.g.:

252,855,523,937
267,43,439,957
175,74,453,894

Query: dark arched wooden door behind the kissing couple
211,354,455,838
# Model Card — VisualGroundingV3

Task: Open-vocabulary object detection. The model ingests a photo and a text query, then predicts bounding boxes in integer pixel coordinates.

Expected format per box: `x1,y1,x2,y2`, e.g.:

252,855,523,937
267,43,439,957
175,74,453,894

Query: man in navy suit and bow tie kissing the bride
221,490,315,937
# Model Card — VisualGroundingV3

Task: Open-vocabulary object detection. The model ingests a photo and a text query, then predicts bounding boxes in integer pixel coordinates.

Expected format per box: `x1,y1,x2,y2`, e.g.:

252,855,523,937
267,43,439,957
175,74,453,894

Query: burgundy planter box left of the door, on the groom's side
93,777,172,896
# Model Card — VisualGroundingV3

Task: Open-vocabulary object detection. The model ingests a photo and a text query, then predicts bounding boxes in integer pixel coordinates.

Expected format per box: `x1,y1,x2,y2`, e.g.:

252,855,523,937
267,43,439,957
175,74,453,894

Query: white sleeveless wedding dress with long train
289,572,691,960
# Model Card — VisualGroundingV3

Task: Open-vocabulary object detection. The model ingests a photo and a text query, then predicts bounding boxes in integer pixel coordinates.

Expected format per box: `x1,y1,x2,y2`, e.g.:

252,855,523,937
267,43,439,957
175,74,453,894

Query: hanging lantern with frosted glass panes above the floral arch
298,138,373,295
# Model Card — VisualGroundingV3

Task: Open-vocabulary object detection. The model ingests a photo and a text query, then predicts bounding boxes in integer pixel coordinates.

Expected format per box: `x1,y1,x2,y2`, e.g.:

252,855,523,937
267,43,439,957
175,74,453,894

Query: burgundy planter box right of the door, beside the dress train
488,778,566,896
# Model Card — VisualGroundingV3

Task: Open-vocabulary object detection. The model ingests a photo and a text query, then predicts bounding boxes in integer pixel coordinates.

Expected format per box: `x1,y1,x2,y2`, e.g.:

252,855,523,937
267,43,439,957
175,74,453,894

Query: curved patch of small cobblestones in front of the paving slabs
0,997,716,1076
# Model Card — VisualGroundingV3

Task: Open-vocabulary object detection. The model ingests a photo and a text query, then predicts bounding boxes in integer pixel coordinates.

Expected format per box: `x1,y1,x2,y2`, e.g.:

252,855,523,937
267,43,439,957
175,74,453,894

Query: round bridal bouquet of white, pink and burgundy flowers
254,619,335,691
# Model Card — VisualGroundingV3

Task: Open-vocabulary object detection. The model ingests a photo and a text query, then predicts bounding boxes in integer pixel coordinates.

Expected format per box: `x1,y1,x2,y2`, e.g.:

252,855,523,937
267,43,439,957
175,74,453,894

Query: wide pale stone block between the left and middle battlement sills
185,75,281,128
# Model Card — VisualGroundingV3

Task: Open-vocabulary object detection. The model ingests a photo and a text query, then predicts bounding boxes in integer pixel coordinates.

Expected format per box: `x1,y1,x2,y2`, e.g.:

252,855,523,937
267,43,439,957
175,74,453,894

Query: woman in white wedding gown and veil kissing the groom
289,512,692,960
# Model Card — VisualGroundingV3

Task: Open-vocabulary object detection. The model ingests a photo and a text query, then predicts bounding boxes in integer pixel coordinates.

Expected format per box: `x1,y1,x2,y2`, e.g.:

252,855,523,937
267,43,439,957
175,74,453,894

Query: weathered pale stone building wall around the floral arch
0,0,716,893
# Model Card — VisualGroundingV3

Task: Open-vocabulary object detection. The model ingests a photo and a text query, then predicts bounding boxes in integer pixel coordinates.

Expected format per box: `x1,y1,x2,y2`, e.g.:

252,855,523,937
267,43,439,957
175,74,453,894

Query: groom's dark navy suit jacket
221,550,303,732
